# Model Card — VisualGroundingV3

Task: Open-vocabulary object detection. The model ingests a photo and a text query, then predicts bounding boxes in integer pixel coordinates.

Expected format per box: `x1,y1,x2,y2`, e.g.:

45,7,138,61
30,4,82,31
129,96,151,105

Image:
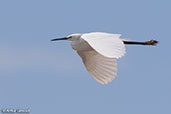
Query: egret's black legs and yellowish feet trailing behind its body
123,40,158,46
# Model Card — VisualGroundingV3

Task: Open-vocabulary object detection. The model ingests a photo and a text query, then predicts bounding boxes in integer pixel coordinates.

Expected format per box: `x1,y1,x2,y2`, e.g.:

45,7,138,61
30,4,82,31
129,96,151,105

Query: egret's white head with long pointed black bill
51,33,82,41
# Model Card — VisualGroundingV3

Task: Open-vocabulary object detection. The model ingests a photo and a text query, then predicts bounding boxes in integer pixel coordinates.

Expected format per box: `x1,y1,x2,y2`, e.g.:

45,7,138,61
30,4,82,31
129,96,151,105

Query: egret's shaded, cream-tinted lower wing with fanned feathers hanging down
77,50,117,84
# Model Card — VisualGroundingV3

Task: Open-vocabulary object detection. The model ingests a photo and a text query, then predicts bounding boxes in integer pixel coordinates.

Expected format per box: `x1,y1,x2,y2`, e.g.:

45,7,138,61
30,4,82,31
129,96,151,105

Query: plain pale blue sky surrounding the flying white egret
0,0,171,114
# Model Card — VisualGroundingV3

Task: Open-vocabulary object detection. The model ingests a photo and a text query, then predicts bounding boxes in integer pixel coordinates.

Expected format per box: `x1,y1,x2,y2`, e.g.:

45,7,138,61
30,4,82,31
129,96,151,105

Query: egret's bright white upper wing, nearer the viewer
81,32,125,58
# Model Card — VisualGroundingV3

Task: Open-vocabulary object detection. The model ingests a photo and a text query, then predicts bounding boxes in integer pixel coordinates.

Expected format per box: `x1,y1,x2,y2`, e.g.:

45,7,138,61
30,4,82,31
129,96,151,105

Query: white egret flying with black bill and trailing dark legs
51,32,158,84
